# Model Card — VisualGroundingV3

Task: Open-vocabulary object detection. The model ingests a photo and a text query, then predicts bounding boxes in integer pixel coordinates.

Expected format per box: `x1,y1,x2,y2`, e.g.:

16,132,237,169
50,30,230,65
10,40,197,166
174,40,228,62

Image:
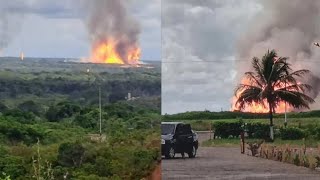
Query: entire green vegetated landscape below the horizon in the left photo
0,58,161,180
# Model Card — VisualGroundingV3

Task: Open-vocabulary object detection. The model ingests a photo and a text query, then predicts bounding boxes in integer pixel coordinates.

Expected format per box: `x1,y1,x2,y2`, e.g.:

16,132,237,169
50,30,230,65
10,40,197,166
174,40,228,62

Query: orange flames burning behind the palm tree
231,78,292,113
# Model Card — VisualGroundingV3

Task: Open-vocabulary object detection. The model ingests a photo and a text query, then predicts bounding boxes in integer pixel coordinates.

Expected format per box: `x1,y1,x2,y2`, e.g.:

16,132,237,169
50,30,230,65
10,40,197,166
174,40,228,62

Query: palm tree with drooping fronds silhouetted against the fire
235,50,314,140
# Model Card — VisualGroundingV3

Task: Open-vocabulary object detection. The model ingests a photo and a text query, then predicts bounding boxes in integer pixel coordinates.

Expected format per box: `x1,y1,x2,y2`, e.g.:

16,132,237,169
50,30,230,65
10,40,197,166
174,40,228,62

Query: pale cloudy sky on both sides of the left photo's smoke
0,0,161,60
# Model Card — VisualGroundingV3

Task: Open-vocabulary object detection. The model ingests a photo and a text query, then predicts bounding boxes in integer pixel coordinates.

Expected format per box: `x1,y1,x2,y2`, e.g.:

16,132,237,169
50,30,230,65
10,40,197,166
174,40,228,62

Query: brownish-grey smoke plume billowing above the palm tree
237,0,320,108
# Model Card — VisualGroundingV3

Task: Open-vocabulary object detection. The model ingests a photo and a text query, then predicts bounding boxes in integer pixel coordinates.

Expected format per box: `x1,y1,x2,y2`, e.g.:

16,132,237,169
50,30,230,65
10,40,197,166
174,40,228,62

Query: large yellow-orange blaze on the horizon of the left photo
91,39,141,64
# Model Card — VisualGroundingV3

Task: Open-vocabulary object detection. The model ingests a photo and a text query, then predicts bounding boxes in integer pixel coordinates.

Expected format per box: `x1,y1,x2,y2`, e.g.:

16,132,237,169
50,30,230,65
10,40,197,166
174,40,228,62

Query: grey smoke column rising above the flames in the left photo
85,0,140,63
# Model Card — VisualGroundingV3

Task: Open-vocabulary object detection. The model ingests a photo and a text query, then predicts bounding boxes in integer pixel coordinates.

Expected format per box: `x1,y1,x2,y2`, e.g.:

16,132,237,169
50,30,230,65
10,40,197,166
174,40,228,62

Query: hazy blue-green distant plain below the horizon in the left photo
0,57,161,109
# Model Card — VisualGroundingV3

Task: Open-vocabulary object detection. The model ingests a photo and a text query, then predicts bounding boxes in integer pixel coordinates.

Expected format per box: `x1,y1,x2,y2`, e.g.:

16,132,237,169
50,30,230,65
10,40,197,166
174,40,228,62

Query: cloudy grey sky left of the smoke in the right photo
162,0,261,114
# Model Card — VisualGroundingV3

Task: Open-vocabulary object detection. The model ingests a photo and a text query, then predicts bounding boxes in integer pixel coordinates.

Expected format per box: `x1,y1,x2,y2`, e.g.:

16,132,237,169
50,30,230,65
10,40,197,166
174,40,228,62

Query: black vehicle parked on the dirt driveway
161,122,198,158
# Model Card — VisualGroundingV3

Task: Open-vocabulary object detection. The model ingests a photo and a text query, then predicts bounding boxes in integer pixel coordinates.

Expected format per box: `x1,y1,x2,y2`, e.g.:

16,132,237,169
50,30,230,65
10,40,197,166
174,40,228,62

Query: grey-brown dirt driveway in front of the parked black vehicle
162,134,320,180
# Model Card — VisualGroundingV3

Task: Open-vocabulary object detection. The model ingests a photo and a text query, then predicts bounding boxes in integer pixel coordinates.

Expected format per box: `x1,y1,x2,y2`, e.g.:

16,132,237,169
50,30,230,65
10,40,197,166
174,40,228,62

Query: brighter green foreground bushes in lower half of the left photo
0,99,160,179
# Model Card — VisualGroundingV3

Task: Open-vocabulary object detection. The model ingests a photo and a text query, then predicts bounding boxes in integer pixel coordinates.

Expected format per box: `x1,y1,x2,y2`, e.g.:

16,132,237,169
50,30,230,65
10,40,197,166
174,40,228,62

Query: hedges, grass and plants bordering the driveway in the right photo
166,111,320,169
